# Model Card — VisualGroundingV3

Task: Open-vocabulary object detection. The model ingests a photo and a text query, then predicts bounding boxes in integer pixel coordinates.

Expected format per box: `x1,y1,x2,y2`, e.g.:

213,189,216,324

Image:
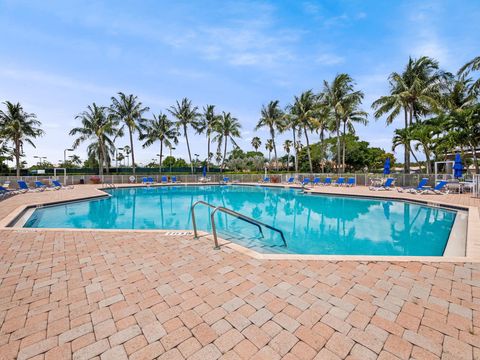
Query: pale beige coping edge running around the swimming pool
0,183,480,262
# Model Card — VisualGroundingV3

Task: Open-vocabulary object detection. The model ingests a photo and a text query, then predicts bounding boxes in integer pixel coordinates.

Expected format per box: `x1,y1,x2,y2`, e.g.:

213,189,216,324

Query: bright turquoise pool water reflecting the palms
25,185,456,256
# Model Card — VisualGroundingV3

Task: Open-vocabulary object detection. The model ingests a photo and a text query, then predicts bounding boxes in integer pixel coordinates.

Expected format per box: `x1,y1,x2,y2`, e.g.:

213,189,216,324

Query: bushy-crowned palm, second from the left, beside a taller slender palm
69,103,121,175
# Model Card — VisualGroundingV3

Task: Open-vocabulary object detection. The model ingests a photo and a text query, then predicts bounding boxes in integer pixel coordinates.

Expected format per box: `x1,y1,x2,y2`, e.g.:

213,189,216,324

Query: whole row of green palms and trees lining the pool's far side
0,56,480,175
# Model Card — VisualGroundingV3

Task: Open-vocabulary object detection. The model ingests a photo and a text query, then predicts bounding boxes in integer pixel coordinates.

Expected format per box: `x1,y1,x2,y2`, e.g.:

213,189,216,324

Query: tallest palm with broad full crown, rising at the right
372,56,445,173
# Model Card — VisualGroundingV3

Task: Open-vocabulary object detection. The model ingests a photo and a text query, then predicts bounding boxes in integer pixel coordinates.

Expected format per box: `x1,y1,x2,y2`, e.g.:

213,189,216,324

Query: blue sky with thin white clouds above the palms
0,0,480,163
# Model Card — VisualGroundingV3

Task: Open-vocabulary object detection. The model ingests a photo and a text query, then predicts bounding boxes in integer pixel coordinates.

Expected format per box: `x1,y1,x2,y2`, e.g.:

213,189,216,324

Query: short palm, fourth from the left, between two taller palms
140,113,178,173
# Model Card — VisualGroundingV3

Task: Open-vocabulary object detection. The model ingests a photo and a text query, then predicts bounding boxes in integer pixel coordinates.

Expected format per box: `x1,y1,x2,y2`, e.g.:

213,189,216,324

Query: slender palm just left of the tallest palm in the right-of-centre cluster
290,90,318,173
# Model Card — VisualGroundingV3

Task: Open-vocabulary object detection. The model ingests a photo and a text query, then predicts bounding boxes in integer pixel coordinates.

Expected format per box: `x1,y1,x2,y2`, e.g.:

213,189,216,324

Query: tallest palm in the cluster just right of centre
322,74,364,172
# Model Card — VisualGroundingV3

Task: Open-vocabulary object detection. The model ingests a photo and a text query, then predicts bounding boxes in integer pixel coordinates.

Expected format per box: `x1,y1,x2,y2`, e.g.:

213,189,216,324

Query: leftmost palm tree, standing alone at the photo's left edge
0,101,44,176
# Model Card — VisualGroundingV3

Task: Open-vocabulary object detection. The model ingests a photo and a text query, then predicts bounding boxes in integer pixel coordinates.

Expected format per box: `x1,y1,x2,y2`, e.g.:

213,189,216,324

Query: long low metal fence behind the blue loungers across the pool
0,173,450,188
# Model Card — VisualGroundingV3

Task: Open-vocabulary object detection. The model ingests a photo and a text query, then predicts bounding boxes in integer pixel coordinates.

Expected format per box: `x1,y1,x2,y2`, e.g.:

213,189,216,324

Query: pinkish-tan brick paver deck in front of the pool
0,187,480,360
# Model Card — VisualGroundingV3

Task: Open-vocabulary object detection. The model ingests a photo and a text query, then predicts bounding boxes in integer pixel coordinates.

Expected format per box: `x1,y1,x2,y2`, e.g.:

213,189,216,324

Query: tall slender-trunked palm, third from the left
110,92,150,174
